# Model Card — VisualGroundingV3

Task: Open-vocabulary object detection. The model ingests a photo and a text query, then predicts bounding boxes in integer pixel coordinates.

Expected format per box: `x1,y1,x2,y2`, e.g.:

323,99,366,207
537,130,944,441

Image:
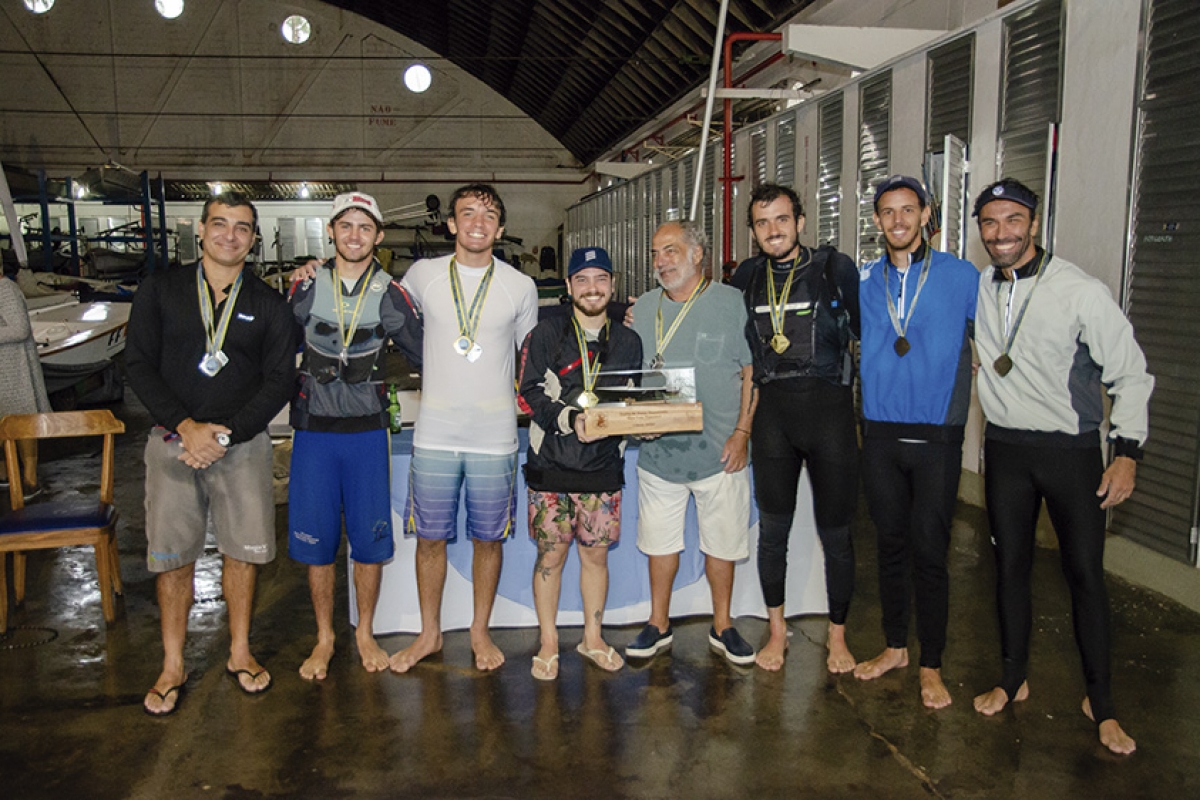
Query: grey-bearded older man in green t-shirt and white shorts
624,222,755,664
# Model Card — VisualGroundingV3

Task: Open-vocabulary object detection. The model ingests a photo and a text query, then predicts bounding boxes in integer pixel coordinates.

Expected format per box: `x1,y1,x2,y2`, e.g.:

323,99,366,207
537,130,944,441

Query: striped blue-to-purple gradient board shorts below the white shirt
404,447,517,542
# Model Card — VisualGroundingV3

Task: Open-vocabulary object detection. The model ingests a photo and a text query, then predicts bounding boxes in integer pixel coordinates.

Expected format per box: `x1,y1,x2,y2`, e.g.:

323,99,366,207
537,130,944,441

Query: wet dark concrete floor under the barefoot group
0,383,1200,799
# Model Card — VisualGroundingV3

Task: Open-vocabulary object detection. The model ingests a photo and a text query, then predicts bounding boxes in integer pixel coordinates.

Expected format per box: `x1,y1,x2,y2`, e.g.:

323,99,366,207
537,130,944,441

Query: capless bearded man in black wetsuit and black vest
732,184,858,673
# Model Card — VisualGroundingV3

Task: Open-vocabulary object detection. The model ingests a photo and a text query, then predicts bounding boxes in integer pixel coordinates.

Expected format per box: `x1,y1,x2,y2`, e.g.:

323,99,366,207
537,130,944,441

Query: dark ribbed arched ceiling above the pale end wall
326,0,814,164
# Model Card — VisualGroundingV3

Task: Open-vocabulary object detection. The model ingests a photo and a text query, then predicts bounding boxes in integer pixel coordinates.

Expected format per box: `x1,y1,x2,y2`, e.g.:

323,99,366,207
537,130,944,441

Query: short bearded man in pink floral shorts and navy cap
521,247,642,680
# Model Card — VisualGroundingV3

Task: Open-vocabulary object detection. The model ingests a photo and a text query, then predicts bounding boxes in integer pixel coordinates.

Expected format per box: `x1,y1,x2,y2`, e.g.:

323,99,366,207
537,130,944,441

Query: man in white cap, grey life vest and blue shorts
288,192,421,680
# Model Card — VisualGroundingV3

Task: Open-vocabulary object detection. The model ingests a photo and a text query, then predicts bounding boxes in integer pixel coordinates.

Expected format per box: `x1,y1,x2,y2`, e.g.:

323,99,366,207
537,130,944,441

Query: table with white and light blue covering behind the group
349,428,827,634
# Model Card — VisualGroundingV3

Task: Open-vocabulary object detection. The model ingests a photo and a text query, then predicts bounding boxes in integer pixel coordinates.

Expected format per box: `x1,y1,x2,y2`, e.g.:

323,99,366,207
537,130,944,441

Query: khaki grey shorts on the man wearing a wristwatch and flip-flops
145,427,275,572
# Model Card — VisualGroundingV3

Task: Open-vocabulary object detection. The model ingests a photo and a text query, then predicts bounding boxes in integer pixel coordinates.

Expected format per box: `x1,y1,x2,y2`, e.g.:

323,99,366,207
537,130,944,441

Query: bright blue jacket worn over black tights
858,249,979,441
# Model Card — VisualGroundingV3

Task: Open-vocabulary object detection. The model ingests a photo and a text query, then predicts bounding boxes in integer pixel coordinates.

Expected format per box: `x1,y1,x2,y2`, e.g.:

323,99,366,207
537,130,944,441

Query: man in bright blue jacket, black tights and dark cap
854,175,979,709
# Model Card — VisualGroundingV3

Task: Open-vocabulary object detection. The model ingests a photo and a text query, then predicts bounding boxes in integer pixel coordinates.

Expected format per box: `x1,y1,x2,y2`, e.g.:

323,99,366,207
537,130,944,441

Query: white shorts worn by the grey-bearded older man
637,467,750,561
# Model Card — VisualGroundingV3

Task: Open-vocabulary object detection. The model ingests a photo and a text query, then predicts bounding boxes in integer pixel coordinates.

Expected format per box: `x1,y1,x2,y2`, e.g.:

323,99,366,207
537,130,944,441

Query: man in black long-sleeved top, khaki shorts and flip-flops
125,193,295,716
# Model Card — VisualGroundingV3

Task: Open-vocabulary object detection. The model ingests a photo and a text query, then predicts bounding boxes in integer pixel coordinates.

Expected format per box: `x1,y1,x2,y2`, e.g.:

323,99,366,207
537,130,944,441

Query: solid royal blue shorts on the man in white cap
288,431,396,566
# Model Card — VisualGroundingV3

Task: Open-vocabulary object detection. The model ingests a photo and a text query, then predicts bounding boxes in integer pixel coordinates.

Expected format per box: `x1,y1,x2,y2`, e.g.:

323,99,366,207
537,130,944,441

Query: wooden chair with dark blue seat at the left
0,409,125,633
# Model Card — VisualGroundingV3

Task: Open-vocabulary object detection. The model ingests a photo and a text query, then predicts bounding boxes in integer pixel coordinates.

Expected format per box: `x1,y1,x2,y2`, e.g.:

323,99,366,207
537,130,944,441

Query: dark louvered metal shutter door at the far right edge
1112,0,1200,564
